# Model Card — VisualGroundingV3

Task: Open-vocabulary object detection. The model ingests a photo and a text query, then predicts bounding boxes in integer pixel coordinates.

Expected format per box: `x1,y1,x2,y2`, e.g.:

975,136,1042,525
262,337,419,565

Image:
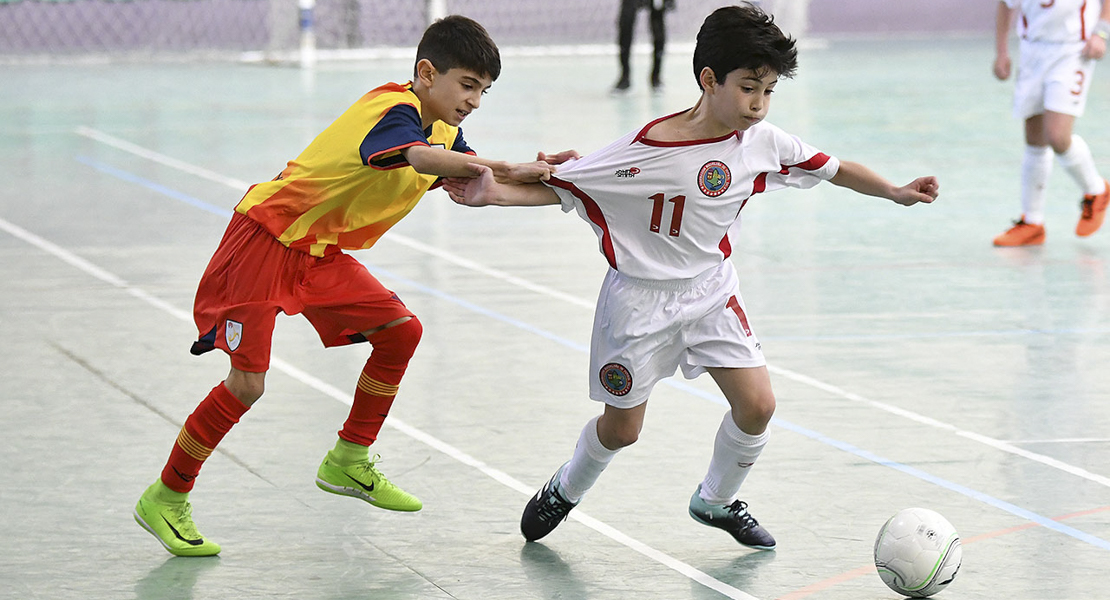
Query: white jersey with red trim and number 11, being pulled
546,110,840,281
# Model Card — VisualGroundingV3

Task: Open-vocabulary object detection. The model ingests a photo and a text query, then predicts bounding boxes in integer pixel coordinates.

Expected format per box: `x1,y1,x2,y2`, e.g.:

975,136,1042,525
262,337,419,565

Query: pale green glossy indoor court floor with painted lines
0,38,1110,600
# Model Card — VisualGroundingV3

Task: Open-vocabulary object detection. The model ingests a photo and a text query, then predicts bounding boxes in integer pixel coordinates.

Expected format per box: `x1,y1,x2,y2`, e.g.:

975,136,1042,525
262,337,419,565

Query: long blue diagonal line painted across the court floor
84,156,1110,550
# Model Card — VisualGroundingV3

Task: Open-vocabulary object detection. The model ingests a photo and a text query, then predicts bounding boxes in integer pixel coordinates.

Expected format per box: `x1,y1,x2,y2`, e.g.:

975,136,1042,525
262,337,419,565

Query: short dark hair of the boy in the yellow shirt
416,14,501,81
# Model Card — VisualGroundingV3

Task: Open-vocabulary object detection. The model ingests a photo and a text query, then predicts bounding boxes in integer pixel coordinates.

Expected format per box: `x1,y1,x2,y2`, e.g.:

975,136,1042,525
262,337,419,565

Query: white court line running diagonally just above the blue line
74,126,1110,487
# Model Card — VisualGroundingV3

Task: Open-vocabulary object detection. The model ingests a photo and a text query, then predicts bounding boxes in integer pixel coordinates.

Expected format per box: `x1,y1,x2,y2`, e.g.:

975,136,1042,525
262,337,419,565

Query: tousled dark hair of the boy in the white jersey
694,3,798,88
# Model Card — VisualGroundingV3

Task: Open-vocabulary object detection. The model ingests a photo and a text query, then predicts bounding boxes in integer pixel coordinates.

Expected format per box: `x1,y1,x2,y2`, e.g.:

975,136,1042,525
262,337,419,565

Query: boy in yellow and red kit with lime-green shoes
134,16,573,556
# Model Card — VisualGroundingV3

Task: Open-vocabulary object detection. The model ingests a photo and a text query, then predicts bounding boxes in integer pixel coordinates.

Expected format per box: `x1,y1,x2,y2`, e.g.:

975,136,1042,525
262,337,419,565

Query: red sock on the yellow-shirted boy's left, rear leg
162,383,248,492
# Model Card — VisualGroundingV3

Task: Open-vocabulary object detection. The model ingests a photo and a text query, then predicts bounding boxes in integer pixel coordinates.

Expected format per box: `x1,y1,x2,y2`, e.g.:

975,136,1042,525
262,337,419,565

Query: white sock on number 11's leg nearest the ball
700,411,769,505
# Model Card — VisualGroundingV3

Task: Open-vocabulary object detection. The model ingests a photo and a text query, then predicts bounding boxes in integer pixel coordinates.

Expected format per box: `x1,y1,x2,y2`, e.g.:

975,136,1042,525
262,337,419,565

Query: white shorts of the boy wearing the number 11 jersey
589,261,767,408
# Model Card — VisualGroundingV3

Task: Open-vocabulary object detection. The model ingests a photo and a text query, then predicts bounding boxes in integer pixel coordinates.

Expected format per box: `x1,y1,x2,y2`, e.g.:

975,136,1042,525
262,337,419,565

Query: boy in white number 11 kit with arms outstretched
446,4,938,550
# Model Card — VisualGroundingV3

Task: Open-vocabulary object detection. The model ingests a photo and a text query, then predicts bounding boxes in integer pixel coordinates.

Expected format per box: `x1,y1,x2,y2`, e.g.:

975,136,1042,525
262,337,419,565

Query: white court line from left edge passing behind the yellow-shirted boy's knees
0,208,757,600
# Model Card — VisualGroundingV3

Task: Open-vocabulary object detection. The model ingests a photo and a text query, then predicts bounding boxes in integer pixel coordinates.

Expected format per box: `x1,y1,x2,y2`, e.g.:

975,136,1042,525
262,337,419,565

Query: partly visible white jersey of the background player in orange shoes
1005,0,1102,43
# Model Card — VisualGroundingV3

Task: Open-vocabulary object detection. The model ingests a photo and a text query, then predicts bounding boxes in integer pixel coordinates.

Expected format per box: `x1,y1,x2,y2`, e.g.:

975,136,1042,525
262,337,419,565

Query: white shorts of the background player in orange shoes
1013,41,1094,121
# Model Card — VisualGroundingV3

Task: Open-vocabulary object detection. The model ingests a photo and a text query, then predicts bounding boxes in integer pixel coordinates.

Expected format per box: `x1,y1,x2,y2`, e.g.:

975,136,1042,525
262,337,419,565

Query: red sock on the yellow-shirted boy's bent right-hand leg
340,317,424,446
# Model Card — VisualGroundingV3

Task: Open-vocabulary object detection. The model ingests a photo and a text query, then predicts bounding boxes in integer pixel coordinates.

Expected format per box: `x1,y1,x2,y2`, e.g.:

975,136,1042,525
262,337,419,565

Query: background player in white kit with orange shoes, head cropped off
995,0,1110,246
